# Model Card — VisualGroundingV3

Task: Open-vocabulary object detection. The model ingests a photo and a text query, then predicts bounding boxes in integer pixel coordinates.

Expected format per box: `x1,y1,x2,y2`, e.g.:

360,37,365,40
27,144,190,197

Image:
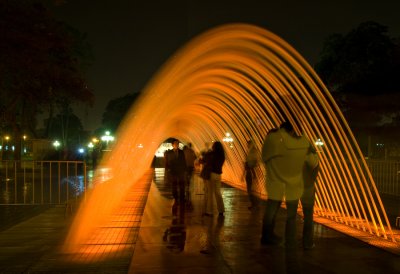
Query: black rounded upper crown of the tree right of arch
316,21,400,95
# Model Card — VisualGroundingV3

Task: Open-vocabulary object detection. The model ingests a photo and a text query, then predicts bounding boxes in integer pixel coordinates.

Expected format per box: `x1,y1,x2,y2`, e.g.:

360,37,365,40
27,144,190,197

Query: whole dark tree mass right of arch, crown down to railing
316,22,400,157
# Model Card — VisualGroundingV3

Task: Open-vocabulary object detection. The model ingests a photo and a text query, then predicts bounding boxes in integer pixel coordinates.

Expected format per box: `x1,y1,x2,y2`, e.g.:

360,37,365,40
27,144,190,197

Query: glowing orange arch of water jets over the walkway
68,24,396,253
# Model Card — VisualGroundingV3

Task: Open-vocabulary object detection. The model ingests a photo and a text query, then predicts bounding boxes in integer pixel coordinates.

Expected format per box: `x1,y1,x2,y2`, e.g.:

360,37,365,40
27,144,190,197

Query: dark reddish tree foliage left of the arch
0,0,93,159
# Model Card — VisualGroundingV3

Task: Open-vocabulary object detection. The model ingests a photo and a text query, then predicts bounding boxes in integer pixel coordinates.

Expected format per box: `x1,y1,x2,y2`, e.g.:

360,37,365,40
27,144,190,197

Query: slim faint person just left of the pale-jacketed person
244,140,258,209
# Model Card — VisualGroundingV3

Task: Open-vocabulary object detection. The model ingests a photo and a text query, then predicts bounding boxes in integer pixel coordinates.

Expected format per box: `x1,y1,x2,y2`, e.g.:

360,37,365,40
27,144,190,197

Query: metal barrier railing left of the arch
0,161,87,204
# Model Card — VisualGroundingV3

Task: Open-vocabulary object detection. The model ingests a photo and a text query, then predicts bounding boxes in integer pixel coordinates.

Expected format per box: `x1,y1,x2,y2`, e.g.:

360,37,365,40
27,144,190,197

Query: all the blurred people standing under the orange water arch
165,122,319,249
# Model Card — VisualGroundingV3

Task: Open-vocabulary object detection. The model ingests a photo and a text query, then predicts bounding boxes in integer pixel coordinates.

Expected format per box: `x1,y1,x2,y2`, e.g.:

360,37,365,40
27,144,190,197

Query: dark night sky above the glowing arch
44,0,400,130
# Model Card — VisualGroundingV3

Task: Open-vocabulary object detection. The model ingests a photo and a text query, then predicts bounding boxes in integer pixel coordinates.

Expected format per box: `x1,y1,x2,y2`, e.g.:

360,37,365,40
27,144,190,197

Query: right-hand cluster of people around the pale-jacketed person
244,122,319,249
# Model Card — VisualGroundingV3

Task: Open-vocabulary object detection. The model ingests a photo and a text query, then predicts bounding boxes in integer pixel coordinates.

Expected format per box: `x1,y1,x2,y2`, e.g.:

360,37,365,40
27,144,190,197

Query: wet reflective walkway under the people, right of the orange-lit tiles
129,170,400,274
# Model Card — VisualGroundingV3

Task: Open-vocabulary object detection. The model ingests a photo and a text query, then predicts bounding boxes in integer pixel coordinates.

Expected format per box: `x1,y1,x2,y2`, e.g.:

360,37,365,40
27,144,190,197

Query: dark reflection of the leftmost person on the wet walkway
163,203,186,253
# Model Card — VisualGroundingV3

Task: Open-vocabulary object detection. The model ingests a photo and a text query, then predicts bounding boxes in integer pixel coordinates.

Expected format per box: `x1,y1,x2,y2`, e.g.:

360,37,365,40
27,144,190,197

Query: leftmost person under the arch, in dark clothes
165,139,186,202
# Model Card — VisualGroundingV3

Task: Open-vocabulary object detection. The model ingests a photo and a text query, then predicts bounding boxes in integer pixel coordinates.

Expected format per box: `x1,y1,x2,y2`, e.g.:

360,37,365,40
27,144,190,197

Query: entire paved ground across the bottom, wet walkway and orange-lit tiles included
0,168,400,274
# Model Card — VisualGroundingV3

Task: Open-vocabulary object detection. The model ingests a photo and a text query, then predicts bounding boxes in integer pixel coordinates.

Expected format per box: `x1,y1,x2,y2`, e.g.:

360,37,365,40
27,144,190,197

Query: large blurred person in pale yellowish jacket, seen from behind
261,122,315,248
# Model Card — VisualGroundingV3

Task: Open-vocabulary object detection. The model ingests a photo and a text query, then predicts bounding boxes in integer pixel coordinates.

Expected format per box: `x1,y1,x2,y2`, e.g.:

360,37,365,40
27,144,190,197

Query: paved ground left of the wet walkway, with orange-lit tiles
0,173,153,273
